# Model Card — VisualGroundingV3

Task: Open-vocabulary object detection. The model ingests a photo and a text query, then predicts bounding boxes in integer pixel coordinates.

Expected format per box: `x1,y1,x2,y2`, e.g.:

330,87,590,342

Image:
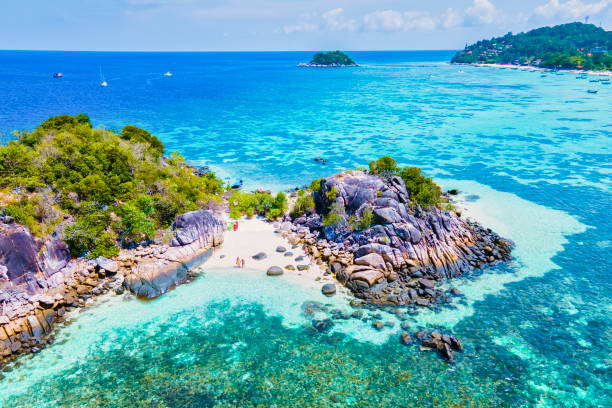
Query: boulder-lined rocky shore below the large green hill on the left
0,210,225,368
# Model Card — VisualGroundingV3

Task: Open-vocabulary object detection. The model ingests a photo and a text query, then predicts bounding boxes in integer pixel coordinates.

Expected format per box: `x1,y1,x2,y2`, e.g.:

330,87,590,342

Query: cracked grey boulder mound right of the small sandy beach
279,171,512,306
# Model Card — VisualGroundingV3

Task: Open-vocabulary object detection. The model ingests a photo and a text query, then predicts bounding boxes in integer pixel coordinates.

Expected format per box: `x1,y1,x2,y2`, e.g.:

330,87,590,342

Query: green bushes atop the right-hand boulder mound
370,156,442,207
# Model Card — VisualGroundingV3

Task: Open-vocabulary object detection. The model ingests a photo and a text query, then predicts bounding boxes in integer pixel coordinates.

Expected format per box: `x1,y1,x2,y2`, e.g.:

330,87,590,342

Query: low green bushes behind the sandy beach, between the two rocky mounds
229,190,287,220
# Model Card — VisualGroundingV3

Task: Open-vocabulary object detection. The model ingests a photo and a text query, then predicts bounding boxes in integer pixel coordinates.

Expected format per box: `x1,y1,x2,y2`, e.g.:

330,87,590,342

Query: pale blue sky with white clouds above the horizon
0,0,612,51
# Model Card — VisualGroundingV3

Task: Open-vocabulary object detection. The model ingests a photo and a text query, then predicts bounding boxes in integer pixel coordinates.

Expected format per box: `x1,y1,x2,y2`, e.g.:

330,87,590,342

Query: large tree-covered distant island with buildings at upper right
451,23,612,71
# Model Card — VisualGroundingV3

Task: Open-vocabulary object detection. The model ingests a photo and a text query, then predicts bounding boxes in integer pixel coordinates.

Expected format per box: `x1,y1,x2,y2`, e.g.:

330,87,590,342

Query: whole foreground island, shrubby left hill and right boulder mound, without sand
0,114,513,368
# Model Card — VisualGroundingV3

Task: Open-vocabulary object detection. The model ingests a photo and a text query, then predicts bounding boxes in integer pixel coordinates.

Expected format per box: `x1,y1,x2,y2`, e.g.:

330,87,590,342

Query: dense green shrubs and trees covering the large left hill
0,114,223,256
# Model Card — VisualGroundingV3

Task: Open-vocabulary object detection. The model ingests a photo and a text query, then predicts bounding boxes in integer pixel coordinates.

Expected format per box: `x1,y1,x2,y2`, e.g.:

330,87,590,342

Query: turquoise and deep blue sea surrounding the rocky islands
0,51,612,408
